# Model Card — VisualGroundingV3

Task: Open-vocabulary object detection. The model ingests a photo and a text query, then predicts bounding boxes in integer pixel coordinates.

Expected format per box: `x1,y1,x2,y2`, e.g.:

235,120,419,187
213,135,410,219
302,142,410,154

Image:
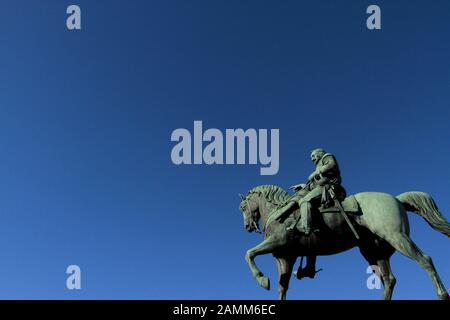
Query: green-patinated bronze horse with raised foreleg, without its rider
239,185,450,300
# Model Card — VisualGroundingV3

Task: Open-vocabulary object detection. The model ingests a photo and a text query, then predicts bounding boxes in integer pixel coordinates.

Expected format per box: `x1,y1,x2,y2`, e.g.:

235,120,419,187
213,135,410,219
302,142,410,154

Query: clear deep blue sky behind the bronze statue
0,0,450,299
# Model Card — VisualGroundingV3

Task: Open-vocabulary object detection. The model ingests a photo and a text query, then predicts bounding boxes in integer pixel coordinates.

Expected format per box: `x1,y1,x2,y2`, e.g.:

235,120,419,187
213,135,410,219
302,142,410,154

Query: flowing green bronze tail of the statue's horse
396,191,450,237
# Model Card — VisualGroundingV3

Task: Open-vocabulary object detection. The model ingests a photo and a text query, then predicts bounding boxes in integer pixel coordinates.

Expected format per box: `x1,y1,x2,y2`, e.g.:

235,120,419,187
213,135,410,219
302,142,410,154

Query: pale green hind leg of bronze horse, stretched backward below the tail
386,233,449,300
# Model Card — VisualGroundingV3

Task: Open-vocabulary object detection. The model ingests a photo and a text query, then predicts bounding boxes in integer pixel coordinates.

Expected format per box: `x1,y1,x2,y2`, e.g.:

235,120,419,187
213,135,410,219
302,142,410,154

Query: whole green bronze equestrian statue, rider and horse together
239,149,450,300
